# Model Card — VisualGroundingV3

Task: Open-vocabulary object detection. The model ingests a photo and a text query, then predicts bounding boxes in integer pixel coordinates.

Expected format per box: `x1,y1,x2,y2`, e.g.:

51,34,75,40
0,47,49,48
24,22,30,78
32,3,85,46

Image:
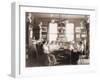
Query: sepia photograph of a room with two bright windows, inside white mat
25,12,90,67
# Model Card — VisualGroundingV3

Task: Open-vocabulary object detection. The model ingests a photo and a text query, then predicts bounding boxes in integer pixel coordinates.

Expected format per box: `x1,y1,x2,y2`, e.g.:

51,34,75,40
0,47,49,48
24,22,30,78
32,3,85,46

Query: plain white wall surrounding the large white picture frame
0,0,100,80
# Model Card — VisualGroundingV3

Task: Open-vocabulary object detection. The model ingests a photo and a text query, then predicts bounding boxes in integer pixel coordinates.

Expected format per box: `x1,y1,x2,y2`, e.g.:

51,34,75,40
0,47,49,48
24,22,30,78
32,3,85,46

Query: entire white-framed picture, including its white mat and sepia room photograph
11,3,95,77
